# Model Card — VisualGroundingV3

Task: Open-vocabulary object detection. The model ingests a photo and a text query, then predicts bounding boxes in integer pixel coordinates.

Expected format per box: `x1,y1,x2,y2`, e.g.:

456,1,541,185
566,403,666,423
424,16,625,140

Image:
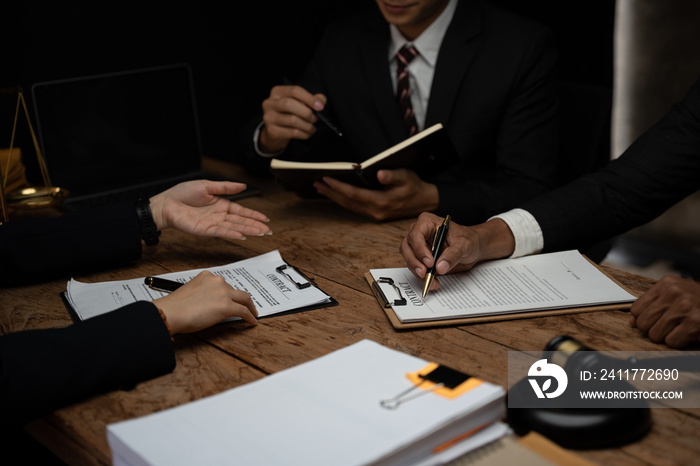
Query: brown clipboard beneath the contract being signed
365,256,640,330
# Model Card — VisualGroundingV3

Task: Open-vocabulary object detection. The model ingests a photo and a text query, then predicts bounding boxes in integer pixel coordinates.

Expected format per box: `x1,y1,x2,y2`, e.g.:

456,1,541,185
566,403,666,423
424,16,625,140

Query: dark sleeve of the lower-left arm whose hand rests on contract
0,301,175,430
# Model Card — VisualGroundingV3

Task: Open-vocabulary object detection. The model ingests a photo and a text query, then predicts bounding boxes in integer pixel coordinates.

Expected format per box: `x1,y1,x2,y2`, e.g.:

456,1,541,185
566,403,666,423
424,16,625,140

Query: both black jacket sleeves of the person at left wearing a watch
0,203,175,430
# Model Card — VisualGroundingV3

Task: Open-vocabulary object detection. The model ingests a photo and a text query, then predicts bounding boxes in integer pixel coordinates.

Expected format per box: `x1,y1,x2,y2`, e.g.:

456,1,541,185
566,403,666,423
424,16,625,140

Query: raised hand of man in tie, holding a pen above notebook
258,86,326,154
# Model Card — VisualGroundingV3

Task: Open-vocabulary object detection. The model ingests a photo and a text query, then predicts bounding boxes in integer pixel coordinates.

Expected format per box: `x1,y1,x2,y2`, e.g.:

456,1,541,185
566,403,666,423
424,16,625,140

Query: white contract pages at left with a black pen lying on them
66,250,331,320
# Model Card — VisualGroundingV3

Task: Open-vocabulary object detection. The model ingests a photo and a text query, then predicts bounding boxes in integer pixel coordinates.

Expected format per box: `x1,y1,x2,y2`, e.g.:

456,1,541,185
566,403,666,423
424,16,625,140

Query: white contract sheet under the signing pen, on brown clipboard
370,251,636,322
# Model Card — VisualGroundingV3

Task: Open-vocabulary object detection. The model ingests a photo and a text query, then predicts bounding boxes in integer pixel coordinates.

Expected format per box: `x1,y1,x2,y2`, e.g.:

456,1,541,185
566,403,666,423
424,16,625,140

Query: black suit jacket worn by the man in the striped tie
251,0,557,223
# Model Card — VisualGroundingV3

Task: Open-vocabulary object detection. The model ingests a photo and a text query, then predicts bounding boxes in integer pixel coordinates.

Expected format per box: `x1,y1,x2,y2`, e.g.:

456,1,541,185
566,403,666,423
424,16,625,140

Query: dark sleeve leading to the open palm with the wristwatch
0,203,141,286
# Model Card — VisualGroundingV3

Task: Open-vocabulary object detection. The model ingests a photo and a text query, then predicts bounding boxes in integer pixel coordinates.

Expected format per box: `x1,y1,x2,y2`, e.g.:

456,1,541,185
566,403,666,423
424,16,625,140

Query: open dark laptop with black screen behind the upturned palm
31,64,254,209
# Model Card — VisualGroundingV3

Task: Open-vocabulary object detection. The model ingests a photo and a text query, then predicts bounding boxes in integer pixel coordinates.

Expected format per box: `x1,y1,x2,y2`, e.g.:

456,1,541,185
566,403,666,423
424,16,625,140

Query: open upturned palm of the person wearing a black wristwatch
150,180,270,239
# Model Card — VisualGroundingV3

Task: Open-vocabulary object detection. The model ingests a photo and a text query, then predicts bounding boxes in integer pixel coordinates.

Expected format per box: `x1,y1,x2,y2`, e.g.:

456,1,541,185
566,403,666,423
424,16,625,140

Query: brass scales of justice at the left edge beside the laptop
0,86,68,224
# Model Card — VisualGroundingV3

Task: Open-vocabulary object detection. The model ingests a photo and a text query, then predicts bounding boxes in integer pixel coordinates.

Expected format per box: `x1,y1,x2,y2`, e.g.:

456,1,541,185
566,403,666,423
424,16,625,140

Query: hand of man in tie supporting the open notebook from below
314,169,439,221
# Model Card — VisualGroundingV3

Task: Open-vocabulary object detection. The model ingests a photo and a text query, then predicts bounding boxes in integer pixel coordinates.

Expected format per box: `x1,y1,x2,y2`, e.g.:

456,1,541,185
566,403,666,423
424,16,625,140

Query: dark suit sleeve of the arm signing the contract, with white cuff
522,76,700,251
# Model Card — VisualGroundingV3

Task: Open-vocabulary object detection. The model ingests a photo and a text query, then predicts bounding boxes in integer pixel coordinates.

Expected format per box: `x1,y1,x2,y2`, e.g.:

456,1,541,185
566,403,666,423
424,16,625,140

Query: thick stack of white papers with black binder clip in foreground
107,340,508,466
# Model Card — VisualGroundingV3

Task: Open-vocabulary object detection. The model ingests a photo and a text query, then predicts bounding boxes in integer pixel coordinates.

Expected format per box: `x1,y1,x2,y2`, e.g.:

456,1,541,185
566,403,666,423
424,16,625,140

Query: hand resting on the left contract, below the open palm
153,270,258,335
